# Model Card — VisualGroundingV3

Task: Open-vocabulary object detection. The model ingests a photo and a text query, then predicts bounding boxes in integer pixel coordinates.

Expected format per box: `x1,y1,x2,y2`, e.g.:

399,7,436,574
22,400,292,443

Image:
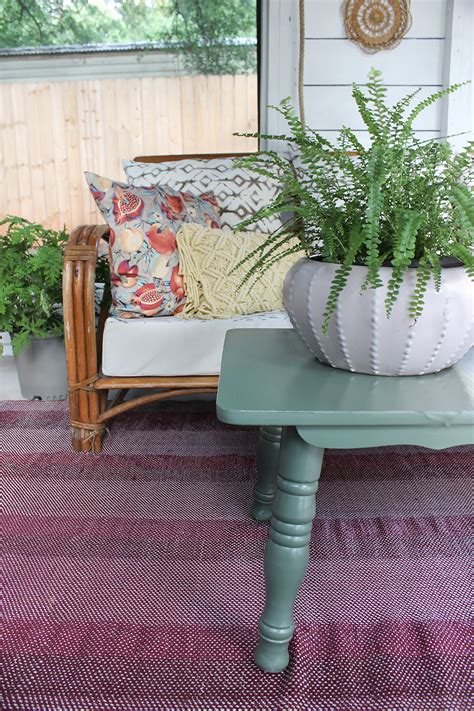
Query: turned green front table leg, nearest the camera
255,427,324,672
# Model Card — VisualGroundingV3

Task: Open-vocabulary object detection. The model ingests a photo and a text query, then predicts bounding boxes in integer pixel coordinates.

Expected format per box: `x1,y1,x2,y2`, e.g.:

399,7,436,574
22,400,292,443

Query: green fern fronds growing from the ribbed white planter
237,69,474,332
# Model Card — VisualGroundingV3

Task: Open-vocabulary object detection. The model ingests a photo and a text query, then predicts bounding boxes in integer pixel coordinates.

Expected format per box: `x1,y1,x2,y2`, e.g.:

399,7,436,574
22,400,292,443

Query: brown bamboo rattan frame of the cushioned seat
63,153,248,452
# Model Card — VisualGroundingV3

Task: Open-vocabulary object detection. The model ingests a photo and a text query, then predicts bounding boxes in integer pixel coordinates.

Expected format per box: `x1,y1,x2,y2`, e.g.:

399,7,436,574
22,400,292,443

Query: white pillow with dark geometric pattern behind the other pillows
123,158,281,232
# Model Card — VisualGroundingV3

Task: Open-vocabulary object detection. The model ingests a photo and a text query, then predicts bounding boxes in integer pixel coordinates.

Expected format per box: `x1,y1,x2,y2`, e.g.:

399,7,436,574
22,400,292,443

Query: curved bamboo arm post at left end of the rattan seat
63,225,109,449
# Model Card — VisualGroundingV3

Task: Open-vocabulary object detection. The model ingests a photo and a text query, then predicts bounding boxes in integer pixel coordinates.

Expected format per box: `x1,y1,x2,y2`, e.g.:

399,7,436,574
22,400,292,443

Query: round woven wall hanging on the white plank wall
342,0,411,53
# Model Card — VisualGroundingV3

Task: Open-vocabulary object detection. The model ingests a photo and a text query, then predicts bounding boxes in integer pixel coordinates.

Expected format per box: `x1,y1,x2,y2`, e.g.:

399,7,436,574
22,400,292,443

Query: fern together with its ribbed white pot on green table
238,69,474,375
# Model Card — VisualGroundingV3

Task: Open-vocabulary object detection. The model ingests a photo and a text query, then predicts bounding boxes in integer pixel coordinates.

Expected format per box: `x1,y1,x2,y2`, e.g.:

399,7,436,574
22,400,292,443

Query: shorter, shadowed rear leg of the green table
251,427,282,521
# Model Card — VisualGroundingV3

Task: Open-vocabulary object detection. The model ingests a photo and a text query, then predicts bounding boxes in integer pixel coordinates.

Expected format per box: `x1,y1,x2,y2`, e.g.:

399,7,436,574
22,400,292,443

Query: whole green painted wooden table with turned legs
217,329,474,672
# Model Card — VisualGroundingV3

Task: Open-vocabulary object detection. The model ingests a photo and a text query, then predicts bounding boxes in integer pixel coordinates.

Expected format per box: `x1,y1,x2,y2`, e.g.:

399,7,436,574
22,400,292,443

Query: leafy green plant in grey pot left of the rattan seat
0,215,67,400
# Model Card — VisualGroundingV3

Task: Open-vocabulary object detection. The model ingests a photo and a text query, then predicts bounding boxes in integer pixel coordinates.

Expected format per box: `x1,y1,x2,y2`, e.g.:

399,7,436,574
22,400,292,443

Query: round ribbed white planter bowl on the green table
283,259,474,375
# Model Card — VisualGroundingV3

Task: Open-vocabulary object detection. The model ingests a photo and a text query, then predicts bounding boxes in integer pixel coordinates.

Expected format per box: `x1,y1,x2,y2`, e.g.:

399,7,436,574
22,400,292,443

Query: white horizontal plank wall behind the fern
262,0,474,146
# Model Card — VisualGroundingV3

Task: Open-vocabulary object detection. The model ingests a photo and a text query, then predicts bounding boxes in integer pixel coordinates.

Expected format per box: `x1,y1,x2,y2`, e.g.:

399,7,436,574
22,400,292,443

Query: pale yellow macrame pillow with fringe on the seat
176,224,304,319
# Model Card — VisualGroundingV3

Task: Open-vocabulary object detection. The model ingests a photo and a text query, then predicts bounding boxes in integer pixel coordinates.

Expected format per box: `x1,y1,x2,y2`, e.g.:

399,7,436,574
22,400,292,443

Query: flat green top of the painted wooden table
217,329,474,432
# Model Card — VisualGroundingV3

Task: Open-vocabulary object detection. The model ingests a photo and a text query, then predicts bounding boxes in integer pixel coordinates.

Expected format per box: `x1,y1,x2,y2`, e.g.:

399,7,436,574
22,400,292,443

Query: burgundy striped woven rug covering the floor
0,402,473,711
